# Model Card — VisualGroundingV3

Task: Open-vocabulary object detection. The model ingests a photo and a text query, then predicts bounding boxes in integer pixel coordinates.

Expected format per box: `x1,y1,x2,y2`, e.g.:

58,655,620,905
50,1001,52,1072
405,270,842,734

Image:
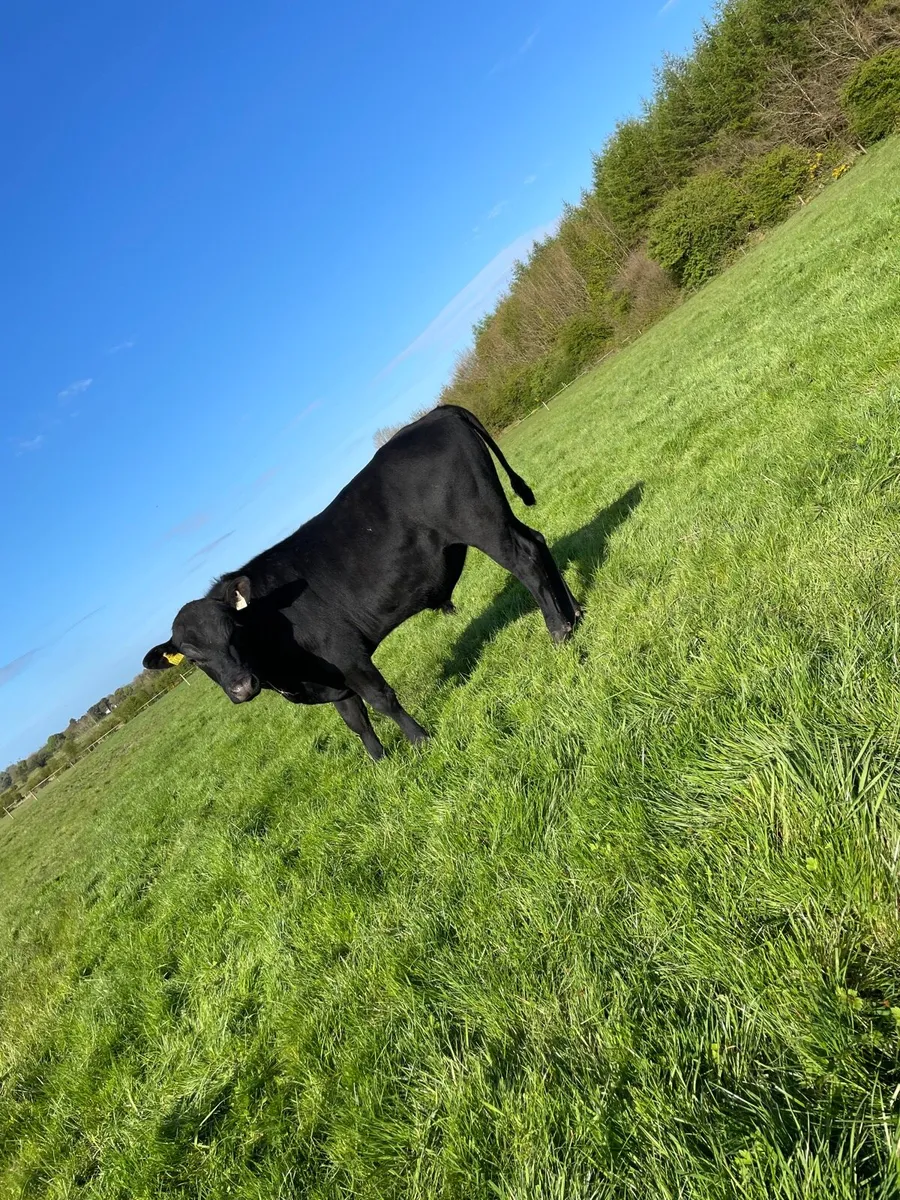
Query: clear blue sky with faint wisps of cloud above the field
0,0,710,767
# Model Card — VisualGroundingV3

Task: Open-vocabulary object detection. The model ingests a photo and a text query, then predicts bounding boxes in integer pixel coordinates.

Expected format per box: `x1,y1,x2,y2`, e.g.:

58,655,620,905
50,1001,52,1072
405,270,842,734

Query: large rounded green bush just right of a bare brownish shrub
648,172,750,288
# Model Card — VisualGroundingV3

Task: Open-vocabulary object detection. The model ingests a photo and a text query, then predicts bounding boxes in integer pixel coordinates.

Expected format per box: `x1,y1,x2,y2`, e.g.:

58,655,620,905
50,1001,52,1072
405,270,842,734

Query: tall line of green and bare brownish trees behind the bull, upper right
376,0,900,445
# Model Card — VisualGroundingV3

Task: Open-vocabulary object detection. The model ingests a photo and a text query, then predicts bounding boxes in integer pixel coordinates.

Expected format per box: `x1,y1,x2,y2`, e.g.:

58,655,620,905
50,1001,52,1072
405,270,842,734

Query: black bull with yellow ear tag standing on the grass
144,404,581,758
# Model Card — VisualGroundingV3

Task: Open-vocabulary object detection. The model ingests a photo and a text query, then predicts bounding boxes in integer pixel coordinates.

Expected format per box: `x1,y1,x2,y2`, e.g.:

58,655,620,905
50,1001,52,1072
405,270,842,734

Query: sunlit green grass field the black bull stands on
0,139,900,1200
